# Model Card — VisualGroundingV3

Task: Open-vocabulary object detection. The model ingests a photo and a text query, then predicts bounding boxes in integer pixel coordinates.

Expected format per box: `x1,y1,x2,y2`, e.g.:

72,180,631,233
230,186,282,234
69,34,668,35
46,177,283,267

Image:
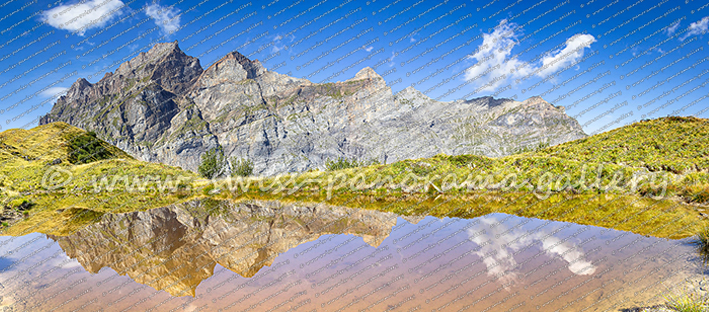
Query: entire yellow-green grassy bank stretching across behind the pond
0,117,709,238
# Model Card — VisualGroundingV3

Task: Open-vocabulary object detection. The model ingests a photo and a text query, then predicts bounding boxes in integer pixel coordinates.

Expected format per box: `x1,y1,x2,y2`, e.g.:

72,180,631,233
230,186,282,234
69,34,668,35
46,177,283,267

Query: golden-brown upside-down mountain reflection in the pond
49,199,397,296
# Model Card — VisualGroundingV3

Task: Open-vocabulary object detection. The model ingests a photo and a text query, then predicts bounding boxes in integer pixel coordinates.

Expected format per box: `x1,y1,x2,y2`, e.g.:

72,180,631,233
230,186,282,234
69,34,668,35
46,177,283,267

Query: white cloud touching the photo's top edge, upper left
42,0,124,36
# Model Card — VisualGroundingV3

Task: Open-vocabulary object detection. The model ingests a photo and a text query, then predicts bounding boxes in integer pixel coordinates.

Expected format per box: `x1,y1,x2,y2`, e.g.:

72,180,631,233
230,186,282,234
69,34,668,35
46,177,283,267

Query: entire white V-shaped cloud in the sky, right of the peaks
465,20,596,92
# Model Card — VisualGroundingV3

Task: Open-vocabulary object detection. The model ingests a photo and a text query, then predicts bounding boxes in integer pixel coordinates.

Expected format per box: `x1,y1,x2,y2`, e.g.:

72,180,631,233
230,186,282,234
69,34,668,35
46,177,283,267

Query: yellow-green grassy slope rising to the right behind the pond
216,118,709,238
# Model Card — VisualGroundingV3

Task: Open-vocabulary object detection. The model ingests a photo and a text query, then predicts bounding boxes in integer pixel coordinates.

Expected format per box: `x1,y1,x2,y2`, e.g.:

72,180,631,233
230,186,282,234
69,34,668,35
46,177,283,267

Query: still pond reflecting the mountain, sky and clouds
0,200,701,311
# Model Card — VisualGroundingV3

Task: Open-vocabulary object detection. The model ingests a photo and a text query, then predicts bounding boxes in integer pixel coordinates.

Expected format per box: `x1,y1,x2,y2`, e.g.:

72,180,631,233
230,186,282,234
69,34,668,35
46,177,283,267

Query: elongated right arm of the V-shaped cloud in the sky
537,34,596,77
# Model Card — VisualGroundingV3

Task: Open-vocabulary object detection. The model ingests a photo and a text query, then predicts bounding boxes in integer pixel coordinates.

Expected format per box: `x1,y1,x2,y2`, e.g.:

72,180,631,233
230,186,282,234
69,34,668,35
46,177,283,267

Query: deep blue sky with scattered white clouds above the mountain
0,0,709,134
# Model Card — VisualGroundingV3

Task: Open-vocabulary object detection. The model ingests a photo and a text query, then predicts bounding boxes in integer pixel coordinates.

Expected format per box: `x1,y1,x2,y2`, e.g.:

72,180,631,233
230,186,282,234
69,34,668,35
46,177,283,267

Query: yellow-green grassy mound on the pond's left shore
0,122,197,234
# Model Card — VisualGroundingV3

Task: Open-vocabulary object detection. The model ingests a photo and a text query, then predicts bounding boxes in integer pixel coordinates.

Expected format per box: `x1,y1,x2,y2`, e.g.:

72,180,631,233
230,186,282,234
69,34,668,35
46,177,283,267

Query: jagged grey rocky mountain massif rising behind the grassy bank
40,42,585,175
